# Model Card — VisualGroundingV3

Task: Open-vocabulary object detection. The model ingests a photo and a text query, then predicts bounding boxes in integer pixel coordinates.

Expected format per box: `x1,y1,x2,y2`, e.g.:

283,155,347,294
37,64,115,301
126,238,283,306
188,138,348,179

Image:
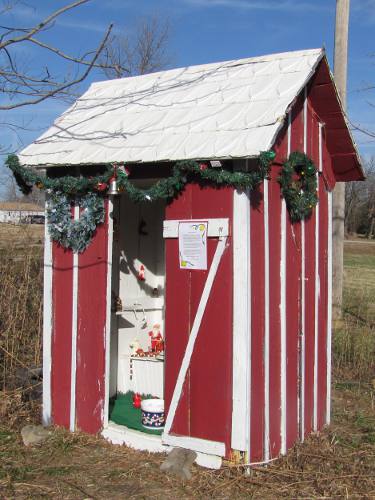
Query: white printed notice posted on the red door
178,222,208,269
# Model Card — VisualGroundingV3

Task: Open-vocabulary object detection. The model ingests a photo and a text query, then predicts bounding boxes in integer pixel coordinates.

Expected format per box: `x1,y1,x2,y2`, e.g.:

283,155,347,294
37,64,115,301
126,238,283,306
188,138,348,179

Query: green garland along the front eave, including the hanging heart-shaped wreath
6,151,275,252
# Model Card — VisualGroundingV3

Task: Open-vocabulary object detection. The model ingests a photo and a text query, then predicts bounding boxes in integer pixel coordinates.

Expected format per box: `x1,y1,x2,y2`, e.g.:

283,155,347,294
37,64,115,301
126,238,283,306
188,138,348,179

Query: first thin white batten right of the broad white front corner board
263,179,270,460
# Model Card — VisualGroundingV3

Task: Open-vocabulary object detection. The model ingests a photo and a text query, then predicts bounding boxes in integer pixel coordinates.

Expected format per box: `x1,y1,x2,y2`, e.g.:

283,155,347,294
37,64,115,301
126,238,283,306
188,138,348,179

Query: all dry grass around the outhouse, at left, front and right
0,227,375,499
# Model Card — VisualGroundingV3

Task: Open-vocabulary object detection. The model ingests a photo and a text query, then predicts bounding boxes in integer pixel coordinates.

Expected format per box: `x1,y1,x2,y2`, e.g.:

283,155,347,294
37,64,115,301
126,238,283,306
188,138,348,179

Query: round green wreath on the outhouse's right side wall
278,151,318,222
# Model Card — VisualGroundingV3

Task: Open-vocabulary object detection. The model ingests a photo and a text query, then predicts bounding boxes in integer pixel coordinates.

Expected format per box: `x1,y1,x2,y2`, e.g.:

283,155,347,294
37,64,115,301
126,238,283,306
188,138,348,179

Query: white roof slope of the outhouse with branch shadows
19,49,324,165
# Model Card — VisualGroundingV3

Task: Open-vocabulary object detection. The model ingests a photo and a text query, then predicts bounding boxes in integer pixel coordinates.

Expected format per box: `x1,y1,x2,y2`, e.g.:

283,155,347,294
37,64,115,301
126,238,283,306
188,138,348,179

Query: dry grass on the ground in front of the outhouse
0,385,375,499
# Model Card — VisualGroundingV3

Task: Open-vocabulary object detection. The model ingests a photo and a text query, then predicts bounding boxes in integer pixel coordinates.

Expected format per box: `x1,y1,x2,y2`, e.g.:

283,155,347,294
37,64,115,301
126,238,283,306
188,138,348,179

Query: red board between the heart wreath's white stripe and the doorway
76,202,108,434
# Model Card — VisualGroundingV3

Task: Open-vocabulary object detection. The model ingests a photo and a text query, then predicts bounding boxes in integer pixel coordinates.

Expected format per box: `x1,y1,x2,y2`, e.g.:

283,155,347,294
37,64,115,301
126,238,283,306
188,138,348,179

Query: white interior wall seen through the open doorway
110,196,165,397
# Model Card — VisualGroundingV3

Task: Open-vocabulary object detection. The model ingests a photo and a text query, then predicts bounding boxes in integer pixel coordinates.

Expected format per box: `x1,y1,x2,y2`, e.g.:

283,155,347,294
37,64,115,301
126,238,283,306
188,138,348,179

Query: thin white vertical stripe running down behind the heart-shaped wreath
69,205,79,432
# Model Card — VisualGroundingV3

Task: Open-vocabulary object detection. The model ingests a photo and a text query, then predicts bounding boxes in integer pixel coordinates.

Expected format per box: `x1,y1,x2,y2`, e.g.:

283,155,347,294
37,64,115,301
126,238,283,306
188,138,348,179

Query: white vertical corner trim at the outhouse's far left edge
42,198,53,425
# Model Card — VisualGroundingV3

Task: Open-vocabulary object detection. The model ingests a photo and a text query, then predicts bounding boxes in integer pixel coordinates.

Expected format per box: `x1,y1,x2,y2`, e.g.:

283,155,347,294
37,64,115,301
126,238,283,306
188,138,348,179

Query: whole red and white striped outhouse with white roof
19,49,363,467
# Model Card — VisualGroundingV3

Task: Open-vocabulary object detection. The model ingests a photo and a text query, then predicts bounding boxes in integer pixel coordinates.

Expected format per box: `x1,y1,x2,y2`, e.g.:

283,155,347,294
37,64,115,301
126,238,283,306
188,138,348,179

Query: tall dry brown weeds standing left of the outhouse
0,224,43,389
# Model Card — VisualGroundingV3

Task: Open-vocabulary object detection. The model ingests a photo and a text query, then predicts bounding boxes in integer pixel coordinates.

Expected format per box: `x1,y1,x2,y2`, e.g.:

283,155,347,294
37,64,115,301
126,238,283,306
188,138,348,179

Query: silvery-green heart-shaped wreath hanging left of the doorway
47,192,104,252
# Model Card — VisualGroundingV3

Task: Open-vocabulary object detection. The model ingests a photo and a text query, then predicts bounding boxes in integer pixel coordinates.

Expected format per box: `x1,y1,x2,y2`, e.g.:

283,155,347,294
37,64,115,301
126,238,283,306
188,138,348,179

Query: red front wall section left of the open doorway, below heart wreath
51,202,108,433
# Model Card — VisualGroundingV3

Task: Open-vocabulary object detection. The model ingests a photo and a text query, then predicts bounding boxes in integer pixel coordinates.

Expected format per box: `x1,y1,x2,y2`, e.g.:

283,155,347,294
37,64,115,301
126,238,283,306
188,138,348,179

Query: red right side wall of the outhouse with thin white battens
250,85,334,462
